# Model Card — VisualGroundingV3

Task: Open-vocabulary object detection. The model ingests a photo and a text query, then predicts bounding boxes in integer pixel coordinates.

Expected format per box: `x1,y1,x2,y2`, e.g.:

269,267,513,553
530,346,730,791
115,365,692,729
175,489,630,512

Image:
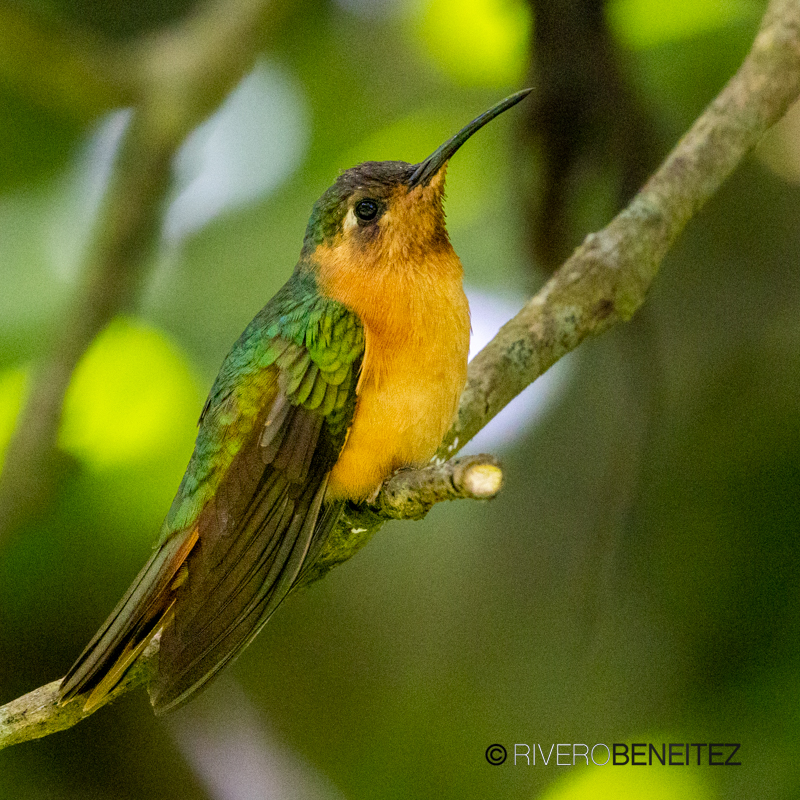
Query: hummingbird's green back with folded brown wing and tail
61,271,364,711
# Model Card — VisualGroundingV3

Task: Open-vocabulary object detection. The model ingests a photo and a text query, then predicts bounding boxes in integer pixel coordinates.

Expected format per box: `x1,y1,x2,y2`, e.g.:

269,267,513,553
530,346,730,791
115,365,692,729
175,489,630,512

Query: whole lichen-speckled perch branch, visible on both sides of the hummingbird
0,0,800,748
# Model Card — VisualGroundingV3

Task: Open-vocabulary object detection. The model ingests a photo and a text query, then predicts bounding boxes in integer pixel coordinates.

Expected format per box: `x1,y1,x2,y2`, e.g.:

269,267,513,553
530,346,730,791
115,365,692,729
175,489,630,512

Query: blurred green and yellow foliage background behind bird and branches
0,0,800,800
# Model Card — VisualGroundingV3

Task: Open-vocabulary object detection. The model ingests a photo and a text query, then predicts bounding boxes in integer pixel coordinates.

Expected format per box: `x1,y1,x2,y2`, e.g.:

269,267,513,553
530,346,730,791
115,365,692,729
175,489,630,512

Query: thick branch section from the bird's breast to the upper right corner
439,0,800,457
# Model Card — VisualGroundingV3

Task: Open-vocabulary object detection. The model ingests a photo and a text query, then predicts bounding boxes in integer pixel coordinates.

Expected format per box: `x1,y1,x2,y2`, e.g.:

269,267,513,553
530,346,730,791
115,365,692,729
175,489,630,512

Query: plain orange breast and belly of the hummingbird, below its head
320,236,470,500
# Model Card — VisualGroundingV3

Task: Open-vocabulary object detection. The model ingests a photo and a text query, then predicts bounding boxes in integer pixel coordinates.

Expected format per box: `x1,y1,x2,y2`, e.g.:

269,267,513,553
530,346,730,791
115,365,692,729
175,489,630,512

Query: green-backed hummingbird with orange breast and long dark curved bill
60,89,531,713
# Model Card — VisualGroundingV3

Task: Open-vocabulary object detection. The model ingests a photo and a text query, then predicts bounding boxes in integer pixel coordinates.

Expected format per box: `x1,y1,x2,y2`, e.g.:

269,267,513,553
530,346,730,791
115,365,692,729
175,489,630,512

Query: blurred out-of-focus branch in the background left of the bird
0,0,268,540
